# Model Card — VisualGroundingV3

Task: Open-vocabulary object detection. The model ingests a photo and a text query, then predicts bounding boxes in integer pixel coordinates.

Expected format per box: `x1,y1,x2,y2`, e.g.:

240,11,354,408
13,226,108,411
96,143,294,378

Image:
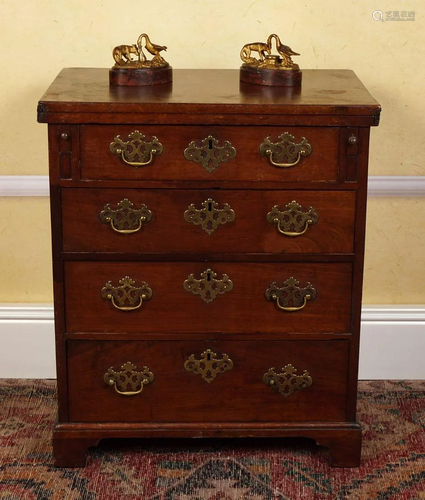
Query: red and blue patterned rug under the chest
0,380,425,500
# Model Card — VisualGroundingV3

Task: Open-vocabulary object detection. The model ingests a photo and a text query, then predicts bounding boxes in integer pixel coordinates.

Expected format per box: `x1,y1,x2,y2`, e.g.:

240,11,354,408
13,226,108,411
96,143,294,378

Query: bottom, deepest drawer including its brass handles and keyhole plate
67,340,350,422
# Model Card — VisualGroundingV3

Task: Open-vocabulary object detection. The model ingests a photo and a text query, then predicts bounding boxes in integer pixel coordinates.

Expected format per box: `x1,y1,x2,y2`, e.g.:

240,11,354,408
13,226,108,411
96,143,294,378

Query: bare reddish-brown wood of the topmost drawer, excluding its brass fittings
80,123,338,182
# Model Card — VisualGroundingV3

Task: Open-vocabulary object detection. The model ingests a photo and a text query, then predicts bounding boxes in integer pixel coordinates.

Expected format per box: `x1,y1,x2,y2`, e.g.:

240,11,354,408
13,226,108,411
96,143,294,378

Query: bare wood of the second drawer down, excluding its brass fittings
62,189,356,254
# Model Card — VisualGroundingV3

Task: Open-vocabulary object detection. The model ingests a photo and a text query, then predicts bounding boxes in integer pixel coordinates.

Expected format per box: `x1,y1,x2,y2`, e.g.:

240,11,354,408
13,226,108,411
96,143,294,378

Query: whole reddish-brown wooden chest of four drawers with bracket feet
38,69,380,466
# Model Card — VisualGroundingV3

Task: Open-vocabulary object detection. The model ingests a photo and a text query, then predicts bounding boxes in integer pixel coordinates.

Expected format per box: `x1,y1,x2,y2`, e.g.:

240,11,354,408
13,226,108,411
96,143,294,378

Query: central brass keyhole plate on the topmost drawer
184,135,236,174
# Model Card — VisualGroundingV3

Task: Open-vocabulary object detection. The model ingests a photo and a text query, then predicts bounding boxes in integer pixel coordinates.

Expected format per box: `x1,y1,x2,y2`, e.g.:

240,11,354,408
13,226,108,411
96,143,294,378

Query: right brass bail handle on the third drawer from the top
266,277,317,312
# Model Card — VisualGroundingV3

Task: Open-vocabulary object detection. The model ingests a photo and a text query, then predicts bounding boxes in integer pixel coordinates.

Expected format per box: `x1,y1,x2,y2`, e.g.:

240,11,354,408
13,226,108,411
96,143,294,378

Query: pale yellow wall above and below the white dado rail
0,0,425,303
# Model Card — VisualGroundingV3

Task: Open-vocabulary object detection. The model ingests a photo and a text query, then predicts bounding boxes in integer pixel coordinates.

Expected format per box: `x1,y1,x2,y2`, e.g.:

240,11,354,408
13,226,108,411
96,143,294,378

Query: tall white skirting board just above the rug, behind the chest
0,304,425,380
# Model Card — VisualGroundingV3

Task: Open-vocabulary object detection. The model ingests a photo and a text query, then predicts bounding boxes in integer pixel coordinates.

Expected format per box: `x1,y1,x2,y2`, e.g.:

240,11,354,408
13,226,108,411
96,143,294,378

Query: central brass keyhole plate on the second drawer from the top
184,198,235,235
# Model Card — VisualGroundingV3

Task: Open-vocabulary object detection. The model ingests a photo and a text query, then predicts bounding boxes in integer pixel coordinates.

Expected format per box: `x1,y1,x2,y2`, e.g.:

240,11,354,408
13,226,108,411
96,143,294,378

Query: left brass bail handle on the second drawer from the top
99,198,152,234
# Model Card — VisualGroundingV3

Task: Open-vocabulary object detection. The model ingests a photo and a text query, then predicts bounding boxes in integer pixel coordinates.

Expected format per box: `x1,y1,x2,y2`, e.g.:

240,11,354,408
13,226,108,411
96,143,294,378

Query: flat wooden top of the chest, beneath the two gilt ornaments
38,68,380,125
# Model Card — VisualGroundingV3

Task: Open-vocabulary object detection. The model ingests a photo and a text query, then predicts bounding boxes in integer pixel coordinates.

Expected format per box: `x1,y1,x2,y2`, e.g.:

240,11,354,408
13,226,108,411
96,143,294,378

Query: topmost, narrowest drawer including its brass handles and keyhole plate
80,125,339,182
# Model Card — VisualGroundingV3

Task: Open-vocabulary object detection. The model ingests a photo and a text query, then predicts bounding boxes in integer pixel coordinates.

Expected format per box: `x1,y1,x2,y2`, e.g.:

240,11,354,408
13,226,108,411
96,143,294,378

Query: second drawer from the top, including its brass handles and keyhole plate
62,189,356,253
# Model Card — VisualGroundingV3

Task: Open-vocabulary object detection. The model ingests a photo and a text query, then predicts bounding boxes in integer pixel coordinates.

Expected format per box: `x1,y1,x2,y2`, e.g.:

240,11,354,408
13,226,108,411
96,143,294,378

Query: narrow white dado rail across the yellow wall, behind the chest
0,175,425,196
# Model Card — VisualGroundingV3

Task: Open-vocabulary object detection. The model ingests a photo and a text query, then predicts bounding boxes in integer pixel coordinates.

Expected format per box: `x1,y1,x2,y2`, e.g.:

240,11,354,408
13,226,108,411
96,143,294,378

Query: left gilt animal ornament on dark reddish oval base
109,33,172,86
